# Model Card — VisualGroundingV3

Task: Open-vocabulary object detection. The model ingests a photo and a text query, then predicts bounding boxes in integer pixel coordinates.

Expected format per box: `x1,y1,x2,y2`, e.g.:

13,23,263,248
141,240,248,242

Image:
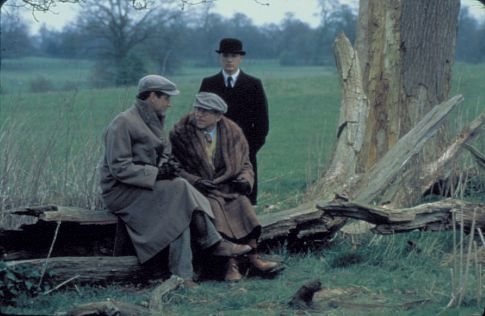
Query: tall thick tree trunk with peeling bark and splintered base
314,0,468,207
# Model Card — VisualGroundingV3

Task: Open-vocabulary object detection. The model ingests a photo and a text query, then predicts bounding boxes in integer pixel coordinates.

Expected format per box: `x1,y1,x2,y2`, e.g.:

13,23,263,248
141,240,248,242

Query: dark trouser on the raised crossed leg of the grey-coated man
190,211,222,249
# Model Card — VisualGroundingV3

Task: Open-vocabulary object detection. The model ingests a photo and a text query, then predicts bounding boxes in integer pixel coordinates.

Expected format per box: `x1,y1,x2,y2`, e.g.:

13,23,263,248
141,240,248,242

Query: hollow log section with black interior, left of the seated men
0,205,117,260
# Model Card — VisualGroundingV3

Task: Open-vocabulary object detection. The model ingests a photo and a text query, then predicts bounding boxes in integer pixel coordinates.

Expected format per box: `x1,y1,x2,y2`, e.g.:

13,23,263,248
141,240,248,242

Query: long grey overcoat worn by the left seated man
99,99,213,263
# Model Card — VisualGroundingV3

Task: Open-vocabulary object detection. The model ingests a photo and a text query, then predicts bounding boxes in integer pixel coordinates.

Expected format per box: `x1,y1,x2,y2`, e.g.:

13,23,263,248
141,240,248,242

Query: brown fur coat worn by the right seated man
170,112,261,241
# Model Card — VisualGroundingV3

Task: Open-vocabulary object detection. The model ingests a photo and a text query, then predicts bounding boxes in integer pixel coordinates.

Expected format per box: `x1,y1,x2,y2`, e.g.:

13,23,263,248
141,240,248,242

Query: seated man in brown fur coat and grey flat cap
170,92,278,281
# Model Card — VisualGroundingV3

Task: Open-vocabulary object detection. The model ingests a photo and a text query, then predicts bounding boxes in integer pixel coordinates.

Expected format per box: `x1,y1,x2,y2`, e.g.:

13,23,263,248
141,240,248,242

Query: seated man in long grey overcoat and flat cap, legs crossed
99,75,251,287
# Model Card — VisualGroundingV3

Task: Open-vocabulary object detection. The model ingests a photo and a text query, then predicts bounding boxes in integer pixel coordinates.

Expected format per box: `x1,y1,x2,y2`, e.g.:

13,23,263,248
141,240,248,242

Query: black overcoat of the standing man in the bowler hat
199,70,269,204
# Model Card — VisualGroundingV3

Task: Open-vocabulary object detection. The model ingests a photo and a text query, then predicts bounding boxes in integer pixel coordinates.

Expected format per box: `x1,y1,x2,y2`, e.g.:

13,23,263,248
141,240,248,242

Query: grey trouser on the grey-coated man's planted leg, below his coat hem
168,229,194,280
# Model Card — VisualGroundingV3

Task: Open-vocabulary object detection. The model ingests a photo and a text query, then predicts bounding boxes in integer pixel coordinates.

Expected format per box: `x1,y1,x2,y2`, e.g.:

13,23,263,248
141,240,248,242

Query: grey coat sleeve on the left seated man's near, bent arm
104,120,158,189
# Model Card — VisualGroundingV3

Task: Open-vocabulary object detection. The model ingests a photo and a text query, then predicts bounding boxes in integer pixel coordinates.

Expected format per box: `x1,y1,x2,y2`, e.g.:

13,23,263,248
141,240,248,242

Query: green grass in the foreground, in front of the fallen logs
4,232,483,316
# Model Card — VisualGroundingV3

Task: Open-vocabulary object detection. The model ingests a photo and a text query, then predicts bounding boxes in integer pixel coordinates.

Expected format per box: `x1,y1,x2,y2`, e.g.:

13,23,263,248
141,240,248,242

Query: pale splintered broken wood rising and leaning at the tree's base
308,34,478,207
